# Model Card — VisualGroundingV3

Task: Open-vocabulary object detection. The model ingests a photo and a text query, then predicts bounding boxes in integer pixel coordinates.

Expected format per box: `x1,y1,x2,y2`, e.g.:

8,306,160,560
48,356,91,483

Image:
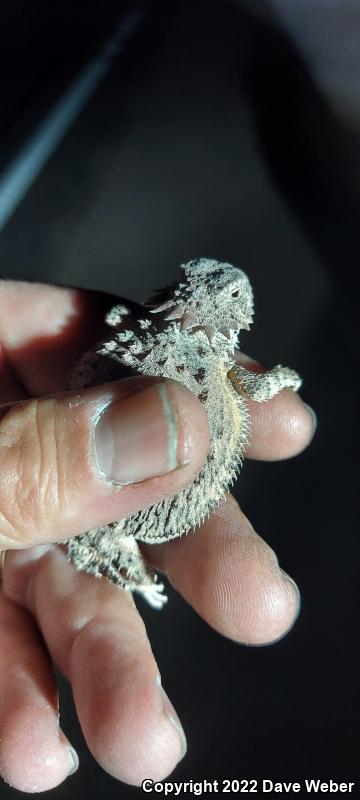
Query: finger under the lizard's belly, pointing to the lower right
150,495,297,644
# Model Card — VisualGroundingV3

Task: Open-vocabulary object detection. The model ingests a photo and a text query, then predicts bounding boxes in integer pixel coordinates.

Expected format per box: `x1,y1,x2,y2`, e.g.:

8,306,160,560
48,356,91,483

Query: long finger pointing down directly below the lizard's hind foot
4,547,185,784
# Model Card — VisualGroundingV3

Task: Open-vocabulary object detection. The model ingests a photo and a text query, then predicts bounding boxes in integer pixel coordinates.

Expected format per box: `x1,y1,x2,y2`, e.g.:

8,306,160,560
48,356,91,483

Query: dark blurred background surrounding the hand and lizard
0,0,360,800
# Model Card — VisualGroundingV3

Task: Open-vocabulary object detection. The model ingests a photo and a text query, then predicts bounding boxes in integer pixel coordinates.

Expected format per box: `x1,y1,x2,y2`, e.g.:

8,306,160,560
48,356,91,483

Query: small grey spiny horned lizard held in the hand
67,258,301,608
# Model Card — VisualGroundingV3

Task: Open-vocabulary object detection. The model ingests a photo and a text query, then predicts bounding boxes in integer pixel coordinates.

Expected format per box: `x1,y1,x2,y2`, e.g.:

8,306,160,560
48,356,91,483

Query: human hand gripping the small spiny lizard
0,282,313,792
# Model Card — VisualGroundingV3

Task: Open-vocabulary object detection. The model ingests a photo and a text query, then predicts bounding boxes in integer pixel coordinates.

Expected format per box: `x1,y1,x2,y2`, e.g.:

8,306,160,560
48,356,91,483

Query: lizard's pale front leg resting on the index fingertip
228,364,302,403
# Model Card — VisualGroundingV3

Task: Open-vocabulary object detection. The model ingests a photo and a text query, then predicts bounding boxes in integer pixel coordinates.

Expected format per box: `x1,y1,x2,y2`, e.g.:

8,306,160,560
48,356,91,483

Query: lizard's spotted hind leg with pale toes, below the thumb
67,526,167,609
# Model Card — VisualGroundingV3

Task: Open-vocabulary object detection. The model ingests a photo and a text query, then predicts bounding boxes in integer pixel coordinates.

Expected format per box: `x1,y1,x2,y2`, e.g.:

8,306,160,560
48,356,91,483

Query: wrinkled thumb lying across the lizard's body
0,377,209,549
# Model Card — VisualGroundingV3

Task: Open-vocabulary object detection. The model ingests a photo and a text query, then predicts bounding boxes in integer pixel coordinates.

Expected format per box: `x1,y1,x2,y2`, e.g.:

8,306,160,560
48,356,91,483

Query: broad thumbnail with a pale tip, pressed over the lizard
95,383,186,484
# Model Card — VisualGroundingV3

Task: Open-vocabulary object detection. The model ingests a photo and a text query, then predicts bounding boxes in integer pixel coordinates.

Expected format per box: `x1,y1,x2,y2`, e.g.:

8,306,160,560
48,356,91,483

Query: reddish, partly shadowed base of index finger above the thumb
0,281,115,400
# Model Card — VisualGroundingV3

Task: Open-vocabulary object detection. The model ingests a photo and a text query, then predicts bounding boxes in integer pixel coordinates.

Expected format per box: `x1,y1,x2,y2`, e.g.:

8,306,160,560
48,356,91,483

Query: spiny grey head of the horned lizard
148,258,253,340
